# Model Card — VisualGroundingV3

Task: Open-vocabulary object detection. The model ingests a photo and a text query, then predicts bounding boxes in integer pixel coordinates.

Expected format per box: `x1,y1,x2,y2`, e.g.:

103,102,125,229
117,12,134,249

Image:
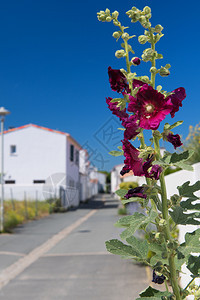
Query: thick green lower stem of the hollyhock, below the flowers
154,136,181,300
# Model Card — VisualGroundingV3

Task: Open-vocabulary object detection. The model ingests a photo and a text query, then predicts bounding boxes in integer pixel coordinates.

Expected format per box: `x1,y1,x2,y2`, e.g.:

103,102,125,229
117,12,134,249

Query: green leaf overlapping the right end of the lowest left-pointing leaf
126,236,148,261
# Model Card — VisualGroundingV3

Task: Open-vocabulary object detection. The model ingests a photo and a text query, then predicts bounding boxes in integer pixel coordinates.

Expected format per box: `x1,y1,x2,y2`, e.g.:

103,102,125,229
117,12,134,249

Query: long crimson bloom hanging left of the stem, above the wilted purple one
122,139,145,176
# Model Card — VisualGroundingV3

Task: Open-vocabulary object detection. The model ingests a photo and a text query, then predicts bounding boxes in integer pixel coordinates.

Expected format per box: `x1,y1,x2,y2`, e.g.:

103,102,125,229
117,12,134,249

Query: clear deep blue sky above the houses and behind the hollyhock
0,0,200,170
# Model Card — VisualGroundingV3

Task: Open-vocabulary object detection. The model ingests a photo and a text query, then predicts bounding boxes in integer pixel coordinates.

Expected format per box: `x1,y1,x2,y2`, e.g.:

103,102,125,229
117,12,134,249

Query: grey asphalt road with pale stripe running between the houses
0,195,149,300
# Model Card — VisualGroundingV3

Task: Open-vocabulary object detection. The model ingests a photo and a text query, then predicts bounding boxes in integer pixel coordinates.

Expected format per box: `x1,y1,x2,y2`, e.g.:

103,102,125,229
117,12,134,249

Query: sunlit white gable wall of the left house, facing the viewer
4,127,66,185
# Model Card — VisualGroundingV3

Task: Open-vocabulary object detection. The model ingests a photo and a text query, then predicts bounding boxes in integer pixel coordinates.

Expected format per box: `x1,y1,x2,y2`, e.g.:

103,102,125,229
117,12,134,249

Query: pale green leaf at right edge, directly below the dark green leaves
178,228,200,257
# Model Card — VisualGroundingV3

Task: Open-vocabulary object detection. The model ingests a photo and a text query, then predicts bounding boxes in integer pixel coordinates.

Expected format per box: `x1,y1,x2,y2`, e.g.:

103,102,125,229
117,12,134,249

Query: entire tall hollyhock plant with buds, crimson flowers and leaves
97,6,200,300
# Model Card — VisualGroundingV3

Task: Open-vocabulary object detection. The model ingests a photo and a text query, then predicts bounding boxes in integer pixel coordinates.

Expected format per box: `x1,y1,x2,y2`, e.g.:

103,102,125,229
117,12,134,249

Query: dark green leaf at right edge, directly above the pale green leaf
169,206,200,225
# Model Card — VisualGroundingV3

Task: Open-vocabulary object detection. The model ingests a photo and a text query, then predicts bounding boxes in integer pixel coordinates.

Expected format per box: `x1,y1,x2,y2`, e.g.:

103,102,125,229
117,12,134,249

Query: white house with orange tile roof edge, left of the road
1,124,81,206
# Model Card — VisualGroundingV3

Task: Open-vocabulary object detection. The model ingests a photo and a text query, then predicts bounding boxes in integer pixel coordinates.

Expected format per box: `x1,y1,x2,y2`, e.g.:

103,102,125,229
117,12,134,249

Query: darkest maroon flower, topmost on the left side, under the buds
108,67,128,93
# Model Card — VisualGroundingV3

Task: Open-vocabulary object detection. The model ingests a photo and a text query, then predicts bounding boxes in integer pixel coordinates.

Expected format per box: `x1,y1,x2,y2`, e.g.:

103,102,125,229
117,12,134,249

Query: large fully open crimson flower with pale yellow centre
128,84,172,130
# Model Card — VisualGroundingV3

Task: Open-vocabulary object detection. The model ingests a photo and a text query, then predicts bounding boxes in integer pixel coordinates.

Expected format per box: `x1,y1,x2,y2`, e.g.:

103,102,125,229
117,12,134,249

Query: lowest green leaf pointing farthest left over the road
106,239,145,261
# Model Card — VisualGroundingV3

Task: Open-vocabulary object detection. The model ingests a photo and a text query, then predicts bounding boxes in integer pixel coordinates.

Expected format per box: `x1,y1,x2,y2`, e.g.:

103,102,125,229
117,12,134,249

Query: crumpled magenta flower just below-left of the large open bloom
122,115,139,140
